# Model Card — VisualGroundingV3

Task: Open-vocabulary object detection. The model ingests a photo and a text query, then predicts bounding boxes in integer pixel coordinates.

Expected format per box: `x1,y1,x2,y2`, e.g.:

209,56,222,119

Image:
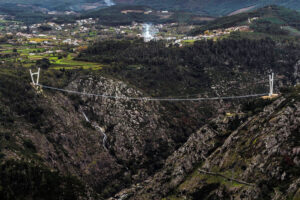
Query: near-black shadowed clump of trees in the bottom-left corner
0,160,87,200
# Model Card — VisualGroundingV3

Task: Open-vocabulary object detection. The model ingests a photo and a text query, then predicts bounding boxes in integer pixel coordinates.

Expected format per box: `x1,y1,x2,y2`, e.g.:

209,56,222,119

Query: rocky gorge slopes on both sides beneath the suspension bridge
0,67,300,200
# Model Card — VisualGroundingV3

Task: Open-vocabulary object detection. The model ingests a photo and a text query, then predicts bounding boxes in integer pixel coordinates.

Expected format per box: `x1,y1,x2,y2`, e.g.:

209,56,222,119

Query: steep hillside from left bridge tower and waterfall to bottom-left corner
0,66,209,199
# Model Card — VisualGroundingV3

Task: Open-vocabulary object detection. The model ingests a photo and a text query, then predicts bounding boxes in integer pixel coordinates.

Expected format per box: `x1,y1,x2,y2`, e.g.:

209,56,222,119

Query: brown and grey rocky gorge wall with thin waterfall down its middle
3,72,206,197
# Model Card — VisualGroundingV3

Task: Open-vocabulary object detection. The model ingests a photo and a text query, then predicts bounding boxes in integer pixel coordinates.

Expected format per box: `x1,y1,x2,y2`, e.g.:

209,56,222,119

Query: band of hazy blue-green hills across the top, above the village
0,0,300,26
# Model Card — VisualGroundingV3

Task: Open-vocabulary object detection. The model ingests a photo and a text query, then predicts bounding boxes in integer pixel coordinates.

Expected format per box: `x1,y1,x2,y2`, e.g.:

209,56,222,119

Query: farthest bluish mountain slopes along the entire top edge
0,0,300,16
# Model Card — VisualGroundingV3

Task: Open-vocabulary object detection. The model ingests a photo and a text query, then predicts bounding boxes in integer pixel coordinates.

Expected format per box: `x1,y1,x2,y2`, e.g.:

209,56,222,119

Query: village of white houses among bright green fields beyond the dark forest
0,11,255,69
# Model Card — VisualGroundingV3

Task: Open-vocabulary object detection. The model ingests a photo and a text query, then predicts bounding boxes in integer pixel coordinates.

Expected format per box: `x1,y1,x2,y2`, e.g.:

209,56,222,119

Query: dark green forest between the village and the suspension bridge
77,38,300,95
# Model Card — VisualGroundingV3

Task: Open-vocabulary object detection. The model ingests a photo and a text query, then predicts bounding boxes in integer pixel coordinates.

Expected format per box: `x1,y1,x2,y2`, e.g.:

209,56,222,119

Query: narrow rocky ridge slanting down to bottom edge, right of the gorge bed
112,125,222,199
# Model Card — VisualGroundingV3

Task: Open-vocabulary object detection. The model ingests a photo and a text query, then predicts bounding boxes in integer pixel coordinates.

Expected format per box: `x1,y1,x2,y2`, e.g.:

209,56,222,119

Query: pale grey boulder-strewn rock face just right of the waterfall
69,77,173,170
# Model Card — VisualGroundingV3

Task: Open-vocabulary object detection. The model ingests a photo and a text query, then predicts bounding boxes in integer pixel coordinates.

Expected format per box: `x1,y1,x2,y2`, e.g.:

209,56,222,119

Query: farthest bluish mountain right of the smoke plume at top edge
115,0,300,16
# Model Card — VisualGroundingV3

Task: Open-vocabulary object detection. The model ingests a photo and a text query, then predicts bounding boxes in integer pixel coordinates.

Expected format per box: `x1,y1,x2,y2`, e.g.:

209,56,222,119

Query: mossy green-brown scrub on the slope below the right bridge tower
164,86,300,200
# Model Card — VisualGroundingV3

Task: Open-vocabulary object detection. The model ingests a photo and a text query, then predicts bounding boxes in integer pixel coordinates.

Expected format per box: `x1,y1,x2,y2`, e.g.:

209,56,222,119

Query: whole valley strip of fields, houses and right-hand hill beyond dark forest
0,4,300,70
